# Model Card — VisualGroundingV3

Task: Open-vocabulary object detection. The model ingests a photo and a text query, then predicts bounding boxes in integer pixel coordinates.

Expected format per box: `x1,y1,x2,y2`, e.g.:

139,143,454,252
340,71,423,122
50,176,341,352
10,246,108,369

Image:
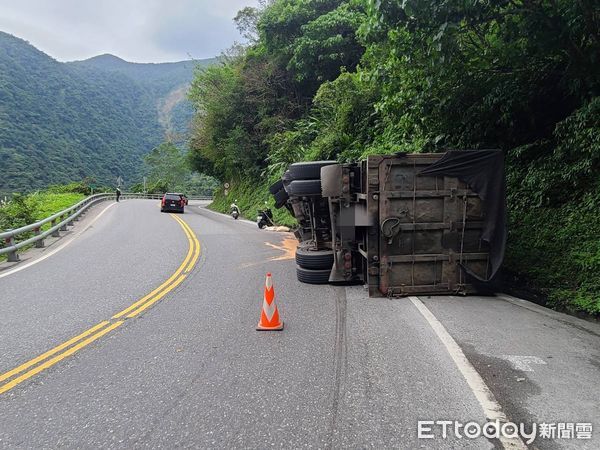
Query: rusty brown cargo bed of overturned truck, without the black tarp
366,154,489,296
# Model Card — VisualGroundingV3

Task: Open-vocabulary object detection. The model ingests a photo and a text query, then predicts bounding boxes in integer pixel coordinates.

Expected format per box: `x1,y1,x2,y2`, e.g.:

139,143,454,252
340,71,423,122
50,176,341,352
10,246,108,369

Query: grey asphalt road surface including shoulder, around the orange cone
0,200,600,449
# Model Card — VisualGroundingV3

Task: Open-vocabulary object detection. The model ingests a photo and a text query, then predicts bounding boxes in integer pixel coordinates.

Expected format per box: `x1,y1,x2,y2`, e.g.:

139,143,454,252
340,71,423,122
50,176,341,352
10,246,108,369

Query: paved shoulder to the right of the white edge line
420,296,600,448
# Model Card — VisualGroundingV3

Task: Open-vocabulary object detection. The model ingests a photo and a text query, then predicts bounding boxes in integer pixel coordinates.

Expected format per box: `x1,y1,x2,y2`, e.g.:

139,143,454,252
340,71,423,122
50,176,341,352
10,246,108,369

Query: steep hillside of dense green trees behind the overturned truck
190,0,600,314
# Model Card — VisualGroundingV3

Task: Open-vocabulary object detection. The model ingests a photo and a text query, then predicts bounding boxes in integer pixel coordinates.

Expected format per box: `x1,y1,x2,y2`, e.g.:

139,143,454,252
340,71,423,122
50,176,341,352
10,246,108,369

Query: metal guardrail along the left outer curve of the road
0,192,212,262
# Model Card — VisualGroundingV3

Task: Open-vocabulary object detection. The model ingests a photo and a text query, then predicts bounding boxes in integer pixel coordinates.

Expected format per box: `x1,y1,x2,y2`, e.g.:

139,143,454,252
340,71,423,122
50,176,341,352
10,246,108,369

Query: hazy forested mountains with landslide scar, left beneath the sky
0,32,213,192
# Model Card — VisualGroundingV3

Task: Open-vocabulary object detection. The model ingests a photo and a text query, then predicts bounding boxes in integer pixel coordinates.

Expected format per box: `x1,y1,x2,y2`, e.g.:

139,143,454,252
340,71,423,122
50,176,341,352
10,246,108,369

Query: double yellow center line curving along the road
0,215,200,394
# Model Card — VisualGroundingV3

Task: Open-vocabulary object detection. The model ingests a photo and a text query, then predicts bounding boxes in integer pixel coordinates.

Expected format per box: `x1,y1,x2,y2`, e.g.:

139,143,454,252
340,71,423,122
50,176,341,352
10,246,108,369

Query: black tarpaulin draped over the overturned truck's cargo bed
420,150,506,281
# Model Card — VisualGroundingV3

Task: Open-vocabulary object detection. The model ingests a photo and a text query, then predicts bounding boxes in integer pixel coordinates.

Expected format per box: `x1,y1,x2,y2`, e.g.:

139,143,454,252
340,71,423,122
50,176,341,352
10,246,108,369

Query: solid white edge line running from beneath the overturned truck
409,297,527,449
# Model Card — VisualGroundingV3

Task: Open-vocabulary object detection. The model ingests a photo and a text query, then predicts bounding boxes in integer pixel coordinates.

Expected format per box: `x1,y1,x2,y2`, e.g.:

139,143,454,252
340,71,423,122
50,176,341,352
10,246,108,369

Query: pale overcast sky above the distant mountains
0,0,257,62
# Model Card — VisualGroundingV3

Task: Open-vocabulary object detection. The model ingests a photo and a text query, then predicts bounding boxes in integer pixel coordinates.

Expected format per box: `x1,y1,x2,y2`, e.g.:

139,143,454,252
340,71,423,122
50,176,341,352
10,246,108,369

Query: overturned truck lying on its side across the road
271,150,506,297
